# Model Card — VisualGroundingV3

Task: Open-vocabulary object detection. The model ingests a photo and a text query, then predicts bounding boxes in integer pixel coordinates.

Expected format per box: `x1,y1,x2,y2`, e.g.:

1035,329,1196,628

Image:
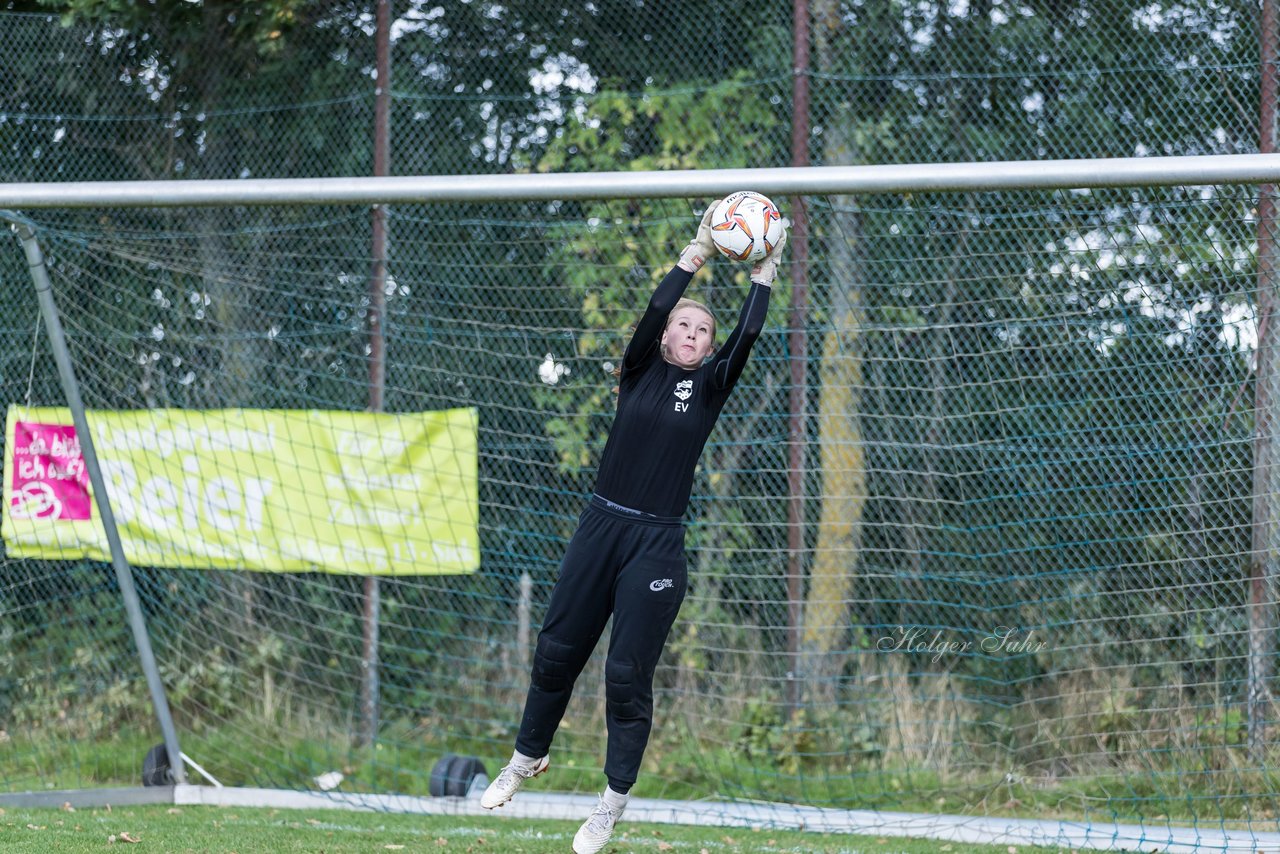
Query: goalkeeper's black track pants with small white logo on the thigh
516,498,687,793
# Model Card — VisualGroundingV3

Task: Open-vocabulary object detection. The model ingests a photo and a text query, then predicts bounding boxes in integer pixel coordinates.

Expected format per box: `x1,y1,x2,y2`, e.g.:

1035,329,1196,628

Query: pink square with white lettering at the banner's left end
9,421,91,520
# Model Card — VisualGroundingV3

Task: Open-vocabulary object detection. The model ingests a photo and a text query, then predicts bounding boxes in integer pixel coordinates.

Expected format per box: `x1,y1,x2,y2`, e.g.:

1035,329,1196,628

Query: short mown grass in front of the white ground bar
0,805,1044,854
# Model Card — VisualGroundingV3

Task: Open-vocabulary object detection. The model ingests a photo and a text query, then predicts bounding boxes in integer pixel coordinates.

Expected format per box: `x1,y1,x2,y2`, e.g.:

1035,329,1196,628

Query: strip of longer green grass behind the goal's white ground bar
0,726,1280,830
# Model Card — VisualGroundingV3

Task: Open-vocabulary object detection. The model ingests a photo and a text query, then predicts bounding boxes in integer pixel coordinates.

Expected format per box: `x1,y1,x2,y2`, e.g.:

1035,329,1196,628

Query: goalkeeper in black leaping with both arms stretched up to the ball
481,205,786,854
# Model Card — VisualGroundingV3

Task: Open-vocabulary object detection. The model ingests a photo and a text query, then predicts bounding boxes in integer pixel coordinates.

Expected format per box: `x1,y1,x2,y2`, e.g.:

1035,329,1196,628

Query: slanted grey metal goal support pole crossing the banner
0,211,187,784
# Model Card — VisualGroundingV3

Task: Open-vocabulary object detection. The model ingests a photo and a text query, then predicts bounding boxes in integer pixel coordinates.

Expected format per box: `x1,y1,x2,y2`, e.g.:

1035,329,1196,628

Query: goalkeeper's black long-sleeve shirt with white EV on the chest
595,266,769,516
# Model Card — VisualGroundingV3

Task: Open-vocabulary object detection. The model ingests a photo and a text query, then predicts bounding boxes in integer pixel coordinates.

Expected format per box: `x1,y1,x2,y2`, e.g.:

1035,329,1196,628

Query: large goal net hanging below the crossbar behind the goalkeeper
0,170,1280,832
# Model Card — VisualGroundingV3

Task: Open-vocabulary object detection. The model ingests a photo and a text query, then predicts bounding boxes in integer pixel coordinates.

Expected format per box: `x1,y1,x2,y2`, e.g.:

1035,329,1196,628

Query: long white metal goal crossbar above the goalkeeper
0,154,1280,209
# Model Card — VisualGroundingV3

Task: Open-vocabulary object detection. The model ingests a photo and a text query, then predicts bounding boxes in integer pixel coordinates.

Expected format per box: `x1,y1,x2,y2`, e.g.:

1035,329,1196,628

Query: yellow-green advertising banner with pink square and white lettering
0,406,480,575
